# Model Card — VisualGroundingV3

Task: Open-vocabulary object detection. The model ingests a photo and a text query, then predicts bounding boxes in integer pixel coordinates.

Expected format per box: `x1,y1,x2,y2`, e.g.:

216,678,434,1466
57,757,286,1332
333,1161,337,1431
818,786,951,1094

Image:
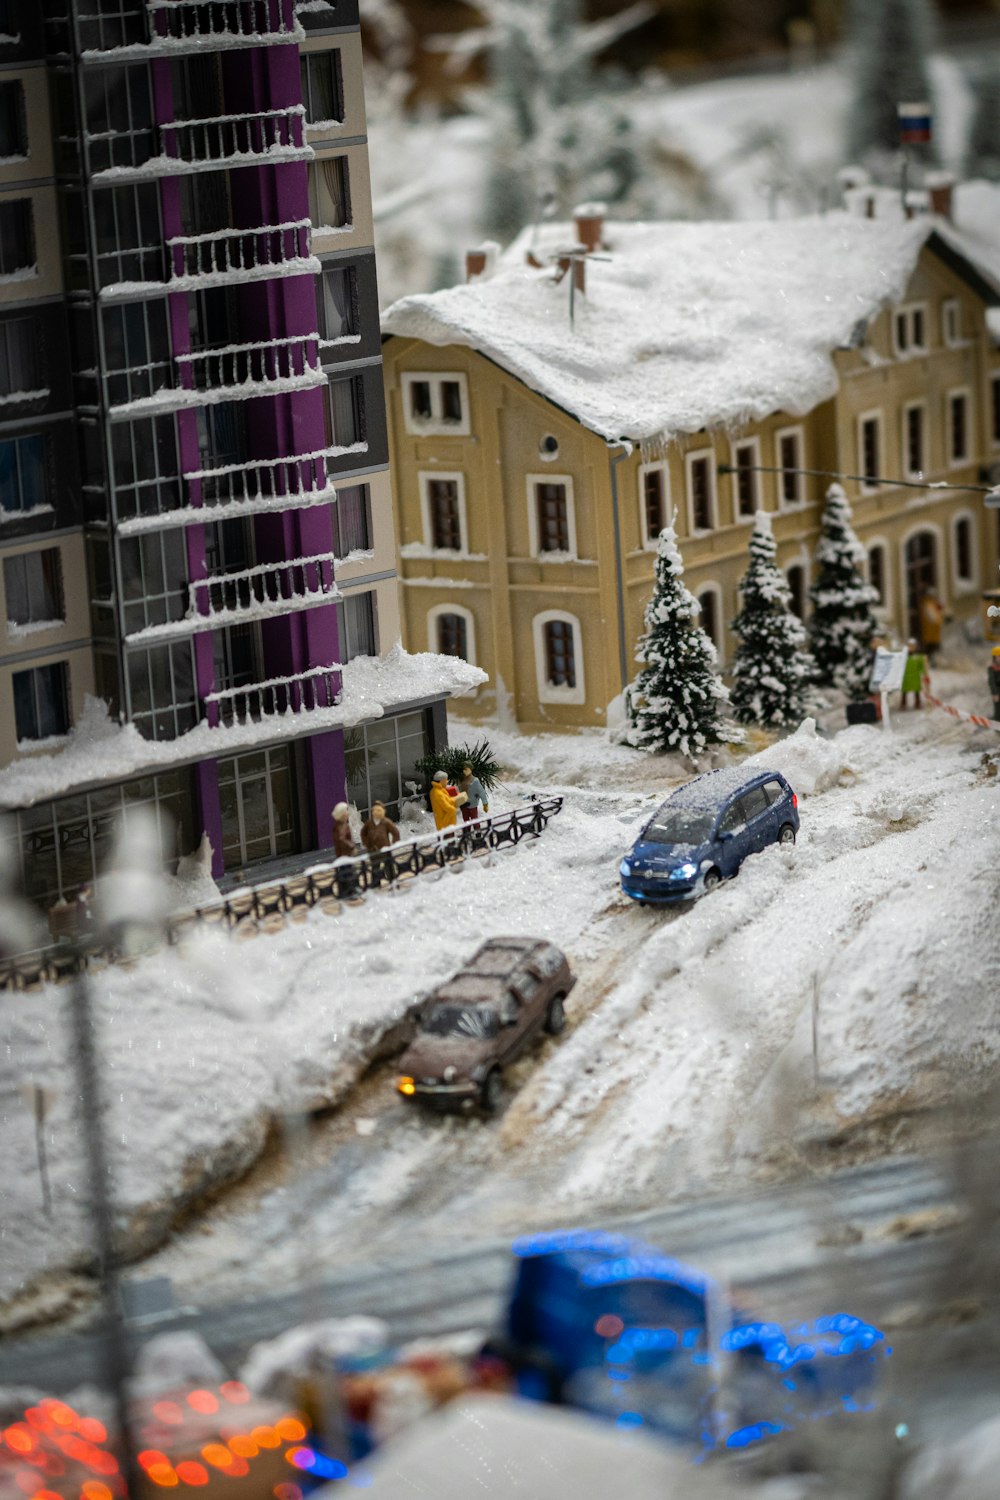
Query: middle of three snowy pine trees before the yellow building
730,510,816,728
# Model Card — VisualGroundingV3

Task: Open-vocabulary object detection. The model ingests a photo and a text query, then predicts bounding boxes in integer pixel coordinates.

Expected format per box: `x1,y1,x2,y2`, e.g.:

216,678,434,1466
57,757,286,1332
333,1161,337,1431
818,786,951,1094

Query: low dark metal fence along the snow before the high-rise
0,797,562,990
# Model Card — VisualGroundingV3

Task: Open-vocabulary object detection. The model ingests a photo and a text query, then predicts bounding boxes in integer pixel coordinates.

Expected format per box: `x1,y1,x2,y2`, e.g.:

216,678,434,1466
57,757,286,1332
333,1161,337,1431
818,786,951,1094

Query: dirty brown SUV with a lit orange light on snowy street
396,938,576,1115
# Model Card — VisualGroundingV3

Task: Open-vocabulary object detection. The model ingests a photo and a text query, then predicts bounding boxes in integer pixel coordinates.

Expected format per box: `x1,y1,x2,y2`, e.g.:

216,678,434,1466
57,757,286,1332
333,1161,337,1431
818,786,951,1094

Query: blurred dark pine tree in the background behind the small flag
847,0,934,162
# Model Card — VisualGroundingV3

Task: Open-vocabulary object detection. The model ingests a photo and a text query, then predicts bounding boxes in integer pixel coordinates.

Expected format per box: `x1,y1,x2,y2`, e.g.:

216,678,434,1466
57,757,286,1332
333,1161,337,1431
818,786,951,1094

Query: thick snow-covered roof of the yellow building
382,213,937,446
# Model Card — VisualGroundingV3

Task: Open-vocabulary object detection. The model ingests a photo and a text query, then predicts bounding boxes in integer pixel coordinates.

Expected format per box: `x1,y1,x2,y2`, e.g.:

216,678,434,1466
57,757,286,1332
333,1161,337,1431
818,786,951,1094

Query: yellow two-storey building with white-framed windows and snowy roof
384,212,1000,729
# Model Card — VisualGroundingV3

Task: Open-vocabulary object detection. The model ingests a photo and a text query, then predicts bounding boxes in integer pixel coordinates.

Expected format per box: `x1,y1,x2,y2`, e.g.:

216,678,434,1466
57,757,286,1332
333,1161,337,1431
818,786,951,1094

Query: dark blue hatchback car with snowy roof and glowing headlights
619,767,799,902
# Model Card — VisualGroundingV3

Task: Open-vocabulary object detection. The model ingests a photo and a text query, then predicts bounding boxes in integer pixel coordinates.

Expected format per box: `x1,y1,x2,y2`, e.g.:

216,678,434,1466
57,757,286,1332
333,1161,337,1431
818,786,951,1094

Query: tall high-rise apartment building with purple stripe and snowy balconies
0,0,473,903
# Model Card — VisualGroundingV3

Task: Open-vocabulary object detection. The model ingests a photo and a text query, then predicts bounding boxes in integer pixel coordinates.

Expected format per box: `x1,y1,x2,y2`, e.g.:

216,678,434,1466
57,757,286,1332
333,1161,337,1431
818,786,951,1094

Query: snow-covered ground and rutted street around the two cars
0,657,1000,1326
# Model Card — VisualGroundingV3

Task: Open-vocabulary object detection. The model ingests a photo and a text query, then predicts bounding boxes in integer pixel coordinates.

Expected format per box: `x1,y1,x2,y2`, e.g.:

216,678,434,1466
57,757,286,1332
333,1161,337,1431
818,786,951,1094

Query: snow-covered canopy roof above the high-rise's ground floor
0,645,486,809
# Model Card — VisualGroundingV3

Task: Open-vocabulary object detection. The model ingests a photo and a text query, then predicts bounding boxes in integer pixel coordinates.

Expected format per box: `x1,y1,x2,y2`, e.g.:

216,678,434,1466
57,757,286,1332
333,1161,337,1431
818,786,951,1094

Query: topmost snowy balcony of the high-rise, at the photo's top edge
74,0,306,62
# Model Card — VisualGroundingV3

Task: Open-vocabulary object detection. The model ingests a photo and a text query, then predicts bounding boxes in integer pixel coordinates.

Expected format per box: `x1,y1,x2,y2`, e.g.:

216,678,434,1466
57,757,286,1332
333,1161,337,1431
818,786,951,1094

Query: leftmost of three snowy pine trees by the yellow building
625,527,731,758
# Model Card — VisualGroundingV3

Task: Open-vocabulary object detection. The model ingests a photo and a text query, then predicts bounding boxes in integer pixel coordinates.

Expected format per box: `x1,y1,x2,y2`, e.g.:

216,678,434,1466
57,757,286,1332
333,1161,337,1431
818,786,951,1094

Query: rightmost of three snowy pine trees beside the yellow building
810,485,880,699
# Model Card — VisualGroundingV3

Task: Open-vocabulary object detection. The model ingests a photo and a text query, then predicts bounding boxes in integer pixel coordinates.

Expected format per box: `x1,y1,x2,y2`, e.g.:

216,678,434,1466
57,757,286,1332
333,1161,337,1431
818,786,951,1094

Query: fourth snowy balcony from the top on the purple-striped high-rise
109,333,327,419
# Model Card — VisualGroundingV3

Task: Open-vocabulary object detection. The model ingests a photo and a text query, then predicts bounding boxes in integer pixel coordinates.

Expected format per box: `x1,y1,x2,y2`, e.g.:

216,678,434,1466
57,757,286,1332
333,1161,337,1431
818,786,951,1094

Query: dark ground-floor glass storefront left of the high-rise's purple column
12,767,198,908
